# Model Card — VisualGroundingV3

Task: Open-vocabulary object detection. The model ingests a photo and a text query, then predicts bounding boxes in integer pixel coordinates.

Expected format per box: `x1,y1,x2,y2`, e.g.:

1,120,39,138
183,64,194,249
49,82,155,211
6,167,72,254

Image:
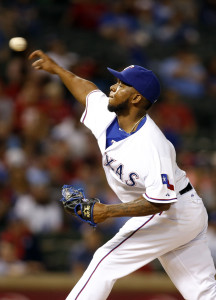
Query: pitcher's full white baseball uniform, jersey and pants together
67,90,216,300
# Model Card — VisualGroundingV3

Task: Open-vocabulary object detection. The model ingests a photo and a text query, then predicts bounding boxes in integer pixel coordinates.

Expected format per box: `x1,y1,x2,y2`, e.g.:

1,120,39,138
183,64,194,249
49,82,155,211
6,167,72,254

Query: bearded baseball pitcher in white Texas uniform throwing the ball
29,50,216,300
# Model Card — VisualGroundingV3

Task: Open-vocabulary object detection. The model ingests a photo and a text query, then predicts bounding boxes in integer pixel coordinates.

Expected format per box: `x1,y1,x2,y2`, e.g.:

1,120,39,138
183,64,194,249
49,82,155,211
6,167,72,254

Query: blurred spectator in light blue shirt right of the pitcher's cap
159,49,206,98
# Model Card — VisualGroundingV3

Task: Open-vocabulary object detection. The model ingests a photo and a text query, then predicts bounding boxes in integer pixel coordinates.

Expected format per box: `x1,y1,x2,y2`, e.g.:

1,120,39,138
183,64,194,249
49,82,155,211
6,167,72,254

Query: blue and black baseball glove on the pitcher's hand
60,185,100,227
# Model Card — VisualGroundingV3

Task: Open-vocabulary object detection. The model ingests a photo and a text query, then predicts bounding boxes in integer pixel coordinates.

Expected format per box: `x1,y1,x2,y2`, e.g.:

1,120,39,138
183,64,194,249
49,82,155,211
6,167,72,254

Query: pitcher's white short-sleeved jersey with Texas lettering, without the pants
81,90,188,203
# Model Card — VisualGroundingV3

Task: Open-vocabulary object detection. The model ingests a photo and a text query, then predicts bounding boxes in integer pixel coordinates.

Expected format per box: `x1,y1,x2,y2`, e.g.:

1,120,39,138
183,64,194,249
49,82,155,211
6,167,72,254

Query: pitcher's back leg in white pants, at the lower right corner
159,239,216,300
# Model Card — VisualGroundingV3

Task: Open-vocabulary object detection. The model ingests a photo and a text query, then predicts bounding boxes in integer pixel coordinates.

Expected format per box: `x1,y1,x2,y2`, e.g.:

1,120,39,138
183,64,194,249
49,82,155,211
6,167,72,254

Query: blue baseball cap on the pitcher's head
107,65,160,103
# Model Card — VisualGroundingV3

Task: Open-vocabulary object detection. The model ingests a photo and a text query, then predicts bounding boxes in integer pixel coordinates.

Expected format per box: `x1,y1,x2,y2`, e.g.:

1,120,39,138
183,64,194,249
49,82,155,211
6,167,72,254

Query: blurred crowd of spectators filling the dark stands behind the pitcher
0,0,216,275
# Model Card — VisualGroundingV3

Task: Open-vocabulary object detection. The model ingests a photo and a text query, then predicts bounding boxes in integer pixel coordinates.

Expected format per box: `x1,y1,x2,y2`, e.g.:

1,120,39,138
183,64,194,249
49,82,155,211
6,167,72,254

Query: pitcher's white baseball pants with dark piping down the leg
66,190,216,300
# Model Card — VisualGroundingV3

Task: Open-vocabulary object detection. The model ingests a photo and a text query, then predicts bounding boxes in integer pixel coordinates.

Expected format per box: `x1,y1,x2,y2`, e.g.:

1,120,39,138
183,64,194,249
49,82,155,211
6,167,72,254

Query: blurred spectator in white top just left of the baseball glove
13,167,63,233
